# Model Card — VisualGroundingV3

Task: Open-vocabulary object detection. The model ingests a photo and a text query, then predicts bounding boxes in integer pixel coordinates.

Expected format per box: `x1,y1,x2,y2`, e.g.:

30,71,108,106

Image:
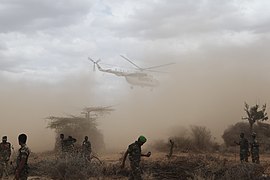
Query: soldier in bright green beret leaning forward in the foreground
121,136,151,180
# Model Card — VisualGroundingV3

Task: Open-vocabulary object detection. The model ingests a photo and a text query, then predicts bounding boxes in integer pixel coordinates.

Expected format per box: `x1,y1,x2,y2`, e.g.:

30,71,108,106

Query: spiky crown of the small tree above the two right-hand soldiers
242,102,268,133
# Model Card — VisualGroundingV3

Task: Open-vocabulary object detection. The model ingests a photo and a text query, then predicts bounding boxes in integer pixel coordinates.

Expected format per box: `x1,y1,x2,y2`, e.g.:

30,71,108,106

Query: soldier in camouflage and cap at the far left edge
0,136,11,178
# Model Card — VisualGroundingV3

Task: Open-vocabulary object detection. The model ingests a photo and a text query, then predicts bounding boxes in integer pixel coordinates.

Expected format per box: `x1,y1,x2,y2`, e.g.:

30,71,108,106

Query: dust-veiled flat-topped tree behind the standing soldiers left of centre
47,107,113,150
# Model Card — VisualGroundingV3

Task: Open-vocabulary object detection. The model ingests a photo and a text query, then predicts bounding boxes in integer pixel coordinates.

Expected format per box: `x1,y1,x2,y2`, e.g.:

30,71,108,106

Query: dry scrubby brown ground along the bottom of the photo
5,152,270,180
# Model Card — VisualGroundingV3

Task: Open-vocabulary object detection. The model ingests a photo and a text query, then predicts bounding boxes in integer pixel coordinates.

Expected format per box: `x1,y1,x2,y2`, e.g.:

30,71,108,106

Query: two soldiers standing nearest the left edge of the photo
0,134,30,180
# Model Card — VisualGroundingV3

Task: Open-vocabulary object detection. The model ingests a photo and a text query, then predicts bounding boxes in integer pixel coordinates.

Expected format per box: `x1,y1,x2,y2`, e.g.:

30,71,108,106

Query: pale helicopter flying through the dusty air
88,55,174,89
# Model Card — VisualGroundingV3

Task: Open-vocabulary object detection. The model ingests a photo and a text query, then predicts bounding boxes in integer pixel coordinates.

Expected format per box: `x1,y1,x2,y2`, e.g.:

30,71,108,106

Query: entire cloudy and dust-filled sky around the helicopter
0,0,270,151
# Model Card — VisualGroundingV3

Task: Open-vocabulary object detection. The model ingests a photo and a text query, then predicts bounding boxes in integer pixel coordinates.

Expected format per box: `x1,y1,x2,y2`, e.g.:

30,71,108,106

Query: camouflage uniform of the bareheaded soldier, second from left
16,144,30,180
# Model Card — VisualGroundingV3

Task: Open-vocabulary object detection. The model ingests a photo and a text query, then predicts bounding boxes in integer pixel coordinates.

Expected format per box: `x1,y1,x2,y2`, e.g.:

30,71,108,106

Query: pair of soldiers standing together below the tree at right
235,132,260,164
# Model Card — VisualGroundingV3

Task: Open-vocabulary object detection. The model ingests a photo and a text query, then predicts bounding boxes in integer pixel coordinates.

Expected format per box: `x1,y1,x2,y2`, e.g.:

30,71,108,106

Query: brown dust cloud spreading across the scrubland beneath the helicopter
0,44,270,151
